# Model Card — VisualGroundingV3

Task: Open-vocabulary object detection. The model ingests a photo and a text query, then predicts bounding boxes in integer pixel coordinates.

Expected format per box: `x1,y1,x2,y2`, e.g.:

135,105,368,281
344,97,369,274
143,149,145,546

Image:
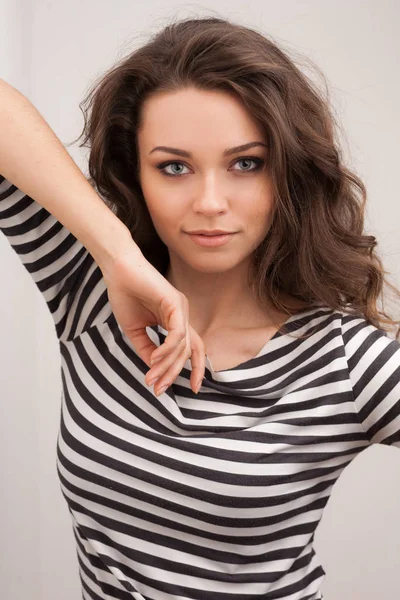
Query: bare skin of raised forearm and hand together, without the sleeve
0,79,205,392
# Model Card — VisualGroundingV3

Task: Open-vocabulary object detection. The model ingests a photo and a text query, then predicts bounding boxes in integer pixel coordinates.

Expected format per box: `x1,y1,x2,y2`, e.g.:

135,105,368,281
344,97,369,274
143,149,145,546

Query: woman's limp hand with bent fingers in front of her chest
102,248,205,395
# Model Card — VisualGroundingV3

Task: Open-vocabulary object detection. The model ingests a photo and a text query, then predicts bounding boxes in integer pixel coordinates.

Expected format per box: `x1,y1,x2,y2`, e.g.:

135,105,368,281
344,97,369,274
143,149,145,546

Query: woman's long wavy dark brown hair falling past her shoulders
71,17,400,338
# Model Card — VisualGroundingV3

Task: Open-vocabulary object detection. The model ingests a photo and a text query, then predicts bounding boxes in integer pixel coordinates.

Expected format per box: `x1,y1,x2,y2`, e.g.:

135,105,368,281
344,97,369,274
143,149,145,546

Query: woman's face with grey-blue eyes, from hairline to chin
138,88,274,273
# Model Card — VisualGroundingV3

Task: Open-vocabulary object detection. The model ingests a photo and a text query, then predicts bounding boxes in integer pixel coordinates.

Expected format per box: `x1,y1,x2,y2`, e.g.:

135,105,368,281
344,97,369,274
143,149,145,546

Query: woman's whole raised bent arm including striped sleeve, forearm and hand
0,79,205,394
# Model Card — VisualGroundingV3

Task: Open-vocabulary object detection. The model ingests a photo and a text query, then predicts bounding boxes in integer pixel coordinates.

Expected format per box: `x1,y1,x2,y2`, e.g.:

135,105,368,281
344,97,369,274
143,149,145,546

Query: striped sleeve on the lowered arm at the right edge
342,315,400,448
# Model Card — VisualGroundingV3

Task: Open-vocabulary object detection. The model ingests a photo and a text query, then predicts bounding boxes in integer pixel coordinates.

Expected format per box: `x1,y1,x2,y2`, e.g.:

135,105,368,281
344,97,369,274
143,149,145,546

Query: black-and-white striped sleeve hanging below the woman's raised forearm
0,175,111,341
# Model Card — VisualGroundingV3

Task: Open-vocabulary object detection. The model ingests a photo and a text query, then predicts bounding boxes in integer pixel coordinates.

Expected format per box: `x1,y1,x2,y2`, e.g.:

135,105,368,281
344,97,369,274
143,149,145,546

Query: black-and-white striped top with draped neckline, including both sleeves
0,173,400,600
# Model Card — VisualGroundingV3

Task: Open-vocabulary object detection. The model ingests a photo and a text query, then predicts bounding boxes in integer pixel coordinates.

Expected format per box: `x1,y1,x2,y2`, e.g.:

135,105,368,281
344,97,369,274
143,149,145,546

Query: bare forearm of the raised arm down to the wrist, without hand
0,79,139,270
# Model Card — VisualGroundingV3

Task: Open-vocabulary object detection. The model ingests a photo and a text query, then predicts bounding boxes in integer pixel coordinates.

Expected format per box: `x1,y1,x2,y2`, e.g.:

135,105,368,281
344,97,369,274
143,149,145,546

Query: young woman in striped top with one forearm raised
0,18,400,600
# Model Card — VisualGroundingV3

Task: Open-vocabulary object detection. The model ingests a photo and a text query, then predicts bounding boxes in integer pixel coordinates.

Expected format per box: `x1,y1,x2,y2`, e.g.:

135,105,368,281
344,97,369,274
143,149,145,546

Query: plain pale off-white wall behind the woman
0,0,400,600
